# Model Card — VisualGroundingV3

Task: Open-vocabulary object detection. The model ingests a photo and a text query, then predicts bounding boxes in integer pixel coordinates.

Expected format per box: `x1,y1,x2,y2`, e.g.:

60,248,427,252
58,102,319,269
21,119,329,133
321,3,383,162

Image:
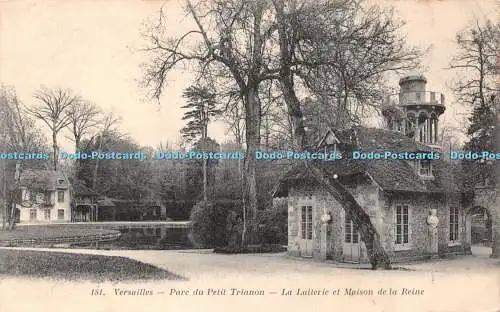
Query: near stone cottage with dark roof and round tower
274,76,473,262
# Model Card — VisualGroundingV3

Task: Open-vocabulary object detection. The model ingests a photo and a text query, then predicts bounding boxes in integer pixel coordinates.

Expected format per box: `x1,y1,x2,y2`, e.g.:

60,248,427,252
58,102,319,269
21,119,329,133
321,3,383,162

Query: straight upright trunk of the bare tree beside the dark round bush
242,85,261,244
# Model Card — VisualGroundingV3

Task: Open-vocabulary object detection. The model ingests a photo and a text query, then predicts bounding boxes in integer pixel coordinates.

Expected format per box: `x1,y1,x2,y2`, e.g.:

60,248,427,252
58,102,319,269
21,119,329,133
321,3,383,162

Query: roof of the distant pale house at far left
19,169,70,191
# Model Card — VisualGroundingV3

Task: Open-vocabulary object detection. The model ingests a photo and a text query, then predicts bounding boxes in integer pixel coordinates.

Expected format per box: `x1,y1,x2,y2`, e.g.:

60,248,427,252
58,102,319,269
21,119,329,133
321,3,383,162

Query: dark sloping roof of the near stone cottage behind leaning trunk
274,127,465,196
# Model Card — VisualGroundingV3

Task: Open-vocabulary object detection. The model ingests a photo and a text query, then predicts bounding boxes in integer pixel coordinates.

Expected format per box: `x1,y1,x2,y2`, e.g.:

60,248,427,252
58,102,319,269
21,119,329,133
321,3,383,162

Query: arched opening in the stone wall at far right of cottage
468,206,493,257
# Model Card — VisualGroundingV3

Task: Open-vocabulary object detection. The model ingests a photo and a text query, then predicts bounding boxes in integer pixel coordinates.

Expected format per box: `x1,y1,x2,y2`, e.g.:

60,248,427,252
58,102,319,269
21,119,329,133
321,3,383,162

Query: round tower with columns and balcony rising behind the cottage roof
382,76,445,147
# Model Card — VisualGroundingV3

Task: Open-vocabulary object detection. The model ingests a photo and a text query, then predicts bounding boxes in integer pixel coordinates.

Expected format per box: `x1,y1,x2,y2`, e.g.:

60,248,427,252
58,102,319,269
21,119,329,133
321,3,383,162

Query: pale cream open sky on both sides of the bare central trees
0,0,498,150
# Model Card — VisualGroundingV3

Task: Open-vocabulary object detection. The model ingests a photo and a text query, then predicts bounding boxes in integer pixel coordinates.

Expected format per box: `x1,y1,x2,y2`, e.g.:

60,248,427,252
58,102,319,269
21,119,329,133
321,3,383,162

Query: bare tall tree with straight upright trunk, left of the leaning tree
144,0,282,244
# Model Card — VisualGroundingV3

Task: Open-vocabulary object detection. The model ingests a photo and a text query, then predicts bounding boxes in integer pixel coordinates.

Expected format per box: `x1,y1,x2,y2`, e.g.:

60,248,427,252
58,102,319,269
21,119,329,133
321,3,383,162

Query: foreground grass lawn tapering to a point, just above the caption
0,249,184,282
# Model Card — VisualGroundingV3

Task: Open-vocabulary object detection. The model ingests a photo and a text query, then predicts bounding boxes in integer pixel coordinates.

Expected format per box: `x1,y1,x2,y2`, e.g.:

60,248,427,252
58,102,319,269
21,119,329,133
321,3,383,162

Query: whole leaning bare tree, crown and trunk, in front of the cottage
273,0,420,269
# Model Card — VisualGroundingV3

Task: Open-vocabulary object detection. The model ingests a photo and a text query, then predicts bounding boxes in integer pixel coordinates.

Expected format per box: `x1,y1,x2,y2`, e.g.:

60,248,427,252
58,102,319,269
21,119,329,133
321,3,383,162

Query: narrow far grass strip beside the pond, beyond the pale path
0,225,118,246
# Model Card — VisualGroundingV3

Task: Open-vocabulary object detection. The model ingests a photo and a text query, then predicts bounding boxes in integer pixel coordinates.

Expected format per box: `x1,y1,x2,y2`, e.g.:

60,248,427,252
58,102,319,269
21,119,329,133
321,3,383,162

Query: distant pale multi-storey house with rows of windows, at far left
16,169,71,223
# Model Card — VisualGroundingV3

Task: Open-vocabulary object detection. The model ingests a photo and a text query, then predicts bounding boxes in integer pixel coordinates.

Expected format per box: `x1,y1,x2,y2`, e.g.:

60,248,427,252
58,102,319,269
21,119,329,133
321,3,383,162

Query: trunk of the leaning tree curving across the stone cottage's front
275,0,391,269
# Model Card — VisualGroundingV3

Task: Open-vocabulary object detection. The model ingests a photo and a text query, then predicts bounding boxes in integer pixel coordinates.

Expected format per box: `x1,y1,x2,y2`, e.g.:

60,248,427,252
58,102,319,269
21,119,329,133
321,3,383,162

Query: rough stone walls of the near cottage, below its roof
288,183,470,262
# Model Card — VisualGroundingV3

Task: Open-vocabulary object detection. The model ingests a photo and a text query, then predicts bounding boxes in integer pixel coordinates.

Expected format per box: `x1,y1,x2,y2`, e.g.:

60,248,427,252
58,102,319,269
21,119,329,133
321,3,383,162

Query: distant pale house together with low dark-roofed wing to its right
15,169,167,223
